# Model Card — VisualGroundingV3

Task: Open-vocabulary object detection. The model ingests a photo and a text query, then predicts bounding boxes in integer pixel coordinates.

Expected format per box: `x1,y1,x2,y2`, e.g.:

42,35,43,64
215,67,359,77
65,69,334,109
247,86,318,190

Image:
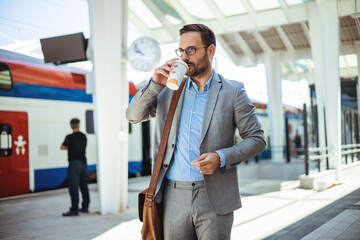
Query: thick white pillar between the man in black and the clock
89,0,129,214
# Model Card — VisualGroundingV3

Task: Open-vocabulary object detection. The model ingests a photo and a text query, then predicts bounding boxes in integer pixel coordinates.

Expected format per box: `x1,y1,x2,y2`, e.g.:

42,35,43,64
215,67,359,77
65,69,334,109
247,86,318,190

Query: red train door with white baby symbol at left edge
0,111,29,197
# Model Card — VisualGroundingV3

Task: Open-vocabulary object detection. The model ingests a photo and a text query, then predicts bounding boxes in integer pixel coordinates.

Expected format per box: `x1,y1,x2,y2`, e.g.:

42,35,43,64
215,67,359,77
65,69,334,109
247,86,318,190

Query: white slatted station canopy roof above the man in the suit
129,0,360,80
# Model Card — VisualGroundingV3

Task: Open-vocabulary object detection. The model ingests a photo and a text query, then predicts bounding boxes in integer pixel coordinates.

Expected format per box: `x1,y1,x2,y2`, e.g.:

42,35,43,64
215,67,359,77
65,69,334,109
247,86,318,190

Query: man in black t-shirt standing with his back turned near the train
60,118,90,217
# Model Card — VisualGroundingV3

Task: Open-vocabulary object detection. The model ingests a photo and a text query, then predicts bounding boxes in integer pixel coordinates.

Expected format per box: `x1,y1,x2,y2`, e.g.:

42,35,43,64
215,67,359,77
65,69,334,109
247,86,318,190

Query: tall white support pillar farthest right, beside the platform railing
308,0,341,180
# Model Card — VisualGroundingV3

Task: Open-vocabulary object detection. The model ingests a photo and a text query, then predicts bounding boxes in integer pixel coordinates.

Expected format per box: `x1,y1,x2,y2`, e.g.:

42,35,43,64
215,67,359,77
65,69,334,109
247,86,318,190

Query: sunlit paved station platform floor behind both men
0,173,360,240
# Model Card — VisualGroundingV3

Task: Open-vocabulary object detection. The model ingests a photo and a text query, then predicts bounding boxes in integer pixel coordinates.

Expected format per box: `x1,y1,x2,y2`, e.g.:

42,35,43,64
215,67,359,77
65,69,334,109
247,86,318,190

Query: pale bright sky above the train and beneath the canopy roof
0,0,309,107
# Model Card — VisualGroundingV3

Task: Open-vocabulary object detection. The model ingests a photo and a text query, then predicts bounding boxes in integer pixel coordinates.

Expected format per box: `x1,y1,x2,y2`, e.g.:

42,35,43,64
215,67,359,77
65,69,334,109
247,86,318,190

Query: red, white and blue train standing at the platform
0,59,302,197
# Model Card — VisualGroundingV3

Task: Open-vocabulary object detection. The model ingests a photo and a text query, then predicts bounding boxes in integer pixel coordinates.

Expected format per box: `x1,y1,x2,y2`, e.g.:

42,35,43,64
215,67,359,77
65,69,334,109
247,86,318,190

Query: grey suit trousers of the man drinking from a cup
164,180,234,240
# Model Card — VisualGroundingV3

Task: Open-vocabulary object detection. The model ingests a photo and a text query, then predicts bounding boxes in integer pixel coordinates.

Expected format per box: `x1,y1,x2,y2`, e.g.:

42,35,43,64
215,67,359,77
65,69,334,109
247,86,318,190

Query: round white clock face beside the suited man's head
127,37,161,72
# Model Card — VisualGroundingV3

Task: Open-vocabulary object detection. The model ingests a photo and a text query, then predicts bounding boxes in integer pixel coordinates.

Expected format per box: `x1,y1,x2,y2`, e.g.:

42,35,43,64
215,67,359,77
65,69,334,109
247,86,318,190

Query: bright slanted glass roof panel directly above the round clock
129,0,162,29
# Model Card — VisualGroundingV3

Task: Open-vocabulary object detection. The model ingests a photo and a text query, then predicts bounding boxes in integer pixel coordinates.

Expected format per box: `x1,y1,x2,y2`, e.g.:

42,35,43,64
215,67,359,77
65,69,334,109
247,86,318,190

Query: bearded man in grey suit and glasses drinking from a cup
126,24,266,240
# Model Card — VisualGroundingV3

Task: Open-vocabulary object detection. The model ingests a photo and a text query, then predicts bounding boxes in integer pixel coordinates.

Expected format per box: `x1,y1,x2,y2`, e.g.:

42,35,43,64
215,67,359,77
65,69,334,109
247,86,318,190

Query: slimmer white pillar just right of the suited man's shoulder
264,54,285,162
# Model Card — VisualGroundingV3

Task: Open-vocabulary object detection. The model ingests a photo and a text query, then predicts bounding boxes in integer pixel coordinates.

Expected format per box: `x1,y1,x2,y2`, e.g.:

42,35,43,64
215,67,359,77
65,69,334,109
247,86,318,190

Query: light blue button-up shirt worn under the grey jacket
167,71,225,182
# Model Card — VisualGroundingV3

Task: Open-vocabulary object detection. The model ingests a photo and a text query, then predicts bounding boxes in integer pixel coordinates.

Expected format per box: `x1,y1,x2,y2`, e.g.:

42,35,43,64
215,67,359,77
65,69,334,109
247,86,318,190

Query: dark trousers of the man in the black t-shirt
67,160,90,212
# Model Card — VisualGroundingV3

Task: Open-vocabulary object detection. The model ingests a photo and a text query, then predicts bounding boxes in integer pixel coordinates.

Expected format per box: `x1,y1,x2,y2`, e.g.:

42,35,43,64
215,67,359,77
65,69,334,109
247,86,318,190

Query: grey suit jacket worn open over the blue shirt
126,72,266,215
